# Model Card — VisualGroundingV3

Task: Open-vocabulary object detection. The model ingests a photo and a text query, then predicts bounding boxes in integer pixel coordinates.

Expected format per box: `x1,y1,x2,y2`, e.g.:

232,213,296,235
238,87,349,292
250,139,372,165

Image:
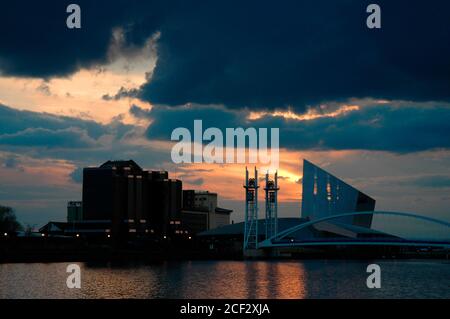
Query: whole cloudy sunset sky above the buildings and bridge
0,0,450,230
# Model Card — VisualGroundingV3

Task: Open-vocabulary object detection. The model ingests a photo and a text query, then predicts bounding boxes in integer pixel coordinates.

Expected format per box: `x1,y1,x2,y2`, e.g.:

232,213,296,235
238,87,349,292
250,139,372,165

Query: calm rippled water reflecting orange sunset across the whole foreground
0,261,450,298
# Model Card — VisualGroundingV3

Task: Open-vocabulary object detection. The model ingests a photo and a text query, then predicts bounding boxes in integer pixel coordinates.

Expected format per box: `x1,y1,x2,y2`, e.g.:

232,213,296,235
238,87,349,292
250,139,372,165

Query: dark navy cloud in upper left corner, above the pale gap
0,0,167,77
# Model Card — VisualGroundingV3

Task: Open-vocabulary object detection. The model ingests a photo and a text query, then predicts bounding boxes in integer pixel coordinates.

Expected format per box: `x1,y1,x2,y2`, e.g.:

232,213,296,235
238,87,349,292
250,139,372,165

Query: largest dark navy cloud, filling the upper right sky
141,0,450,110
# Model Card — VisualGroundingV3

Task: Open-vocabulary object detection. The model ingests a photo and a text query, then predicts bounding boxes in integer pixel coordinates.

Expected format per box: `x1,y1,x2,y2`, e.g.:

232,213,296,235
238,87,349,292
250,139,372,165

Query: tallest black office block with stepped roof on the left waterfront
83,160,182,235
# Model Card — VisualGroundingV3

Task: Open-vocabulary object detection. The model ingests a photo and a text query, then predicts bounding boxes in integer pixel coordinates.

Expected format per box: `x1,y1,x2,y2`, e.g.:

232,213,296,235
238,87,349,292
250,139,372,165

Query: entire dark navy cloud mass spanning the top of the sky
0,0,450,110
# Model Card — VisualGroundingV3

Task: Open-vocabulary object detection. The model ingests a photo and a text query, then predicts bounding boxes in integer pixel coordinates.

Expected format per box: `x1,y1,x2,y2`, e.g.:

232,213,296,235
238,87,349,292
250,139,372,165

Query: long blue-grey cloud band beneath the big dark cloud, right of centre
134,102,450,153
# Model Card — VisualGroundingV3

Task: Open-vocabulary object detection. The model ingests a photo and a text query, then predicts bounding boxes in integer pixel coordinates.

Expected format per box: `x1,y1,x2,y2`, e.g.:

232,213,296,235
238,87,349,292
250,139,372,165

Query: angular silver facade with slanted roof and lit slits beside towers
302,160,375,228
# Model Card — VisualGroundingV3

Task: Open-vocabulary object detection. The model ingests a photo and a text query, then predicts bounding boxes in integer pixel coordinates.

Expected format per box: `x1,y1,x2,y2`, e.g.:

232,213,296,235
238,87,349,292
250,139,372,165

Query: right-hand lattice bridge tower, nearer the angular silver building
264,172,280,238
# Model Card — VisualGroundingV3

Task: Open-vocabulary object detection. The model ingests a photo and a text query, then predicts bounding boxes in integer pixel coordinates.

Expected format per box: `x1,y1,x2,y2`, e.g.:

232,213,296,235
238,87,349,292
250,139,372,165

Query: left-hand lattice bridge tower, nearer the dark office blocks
243,167,259,252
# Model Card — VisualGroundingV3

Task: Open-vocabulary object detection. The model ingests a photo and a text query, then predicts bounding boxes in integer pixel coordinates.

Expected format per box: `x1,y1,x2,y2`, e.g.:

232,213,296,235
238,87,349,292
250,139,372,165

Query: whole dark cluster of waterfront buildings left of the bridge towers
40,160,232,242
